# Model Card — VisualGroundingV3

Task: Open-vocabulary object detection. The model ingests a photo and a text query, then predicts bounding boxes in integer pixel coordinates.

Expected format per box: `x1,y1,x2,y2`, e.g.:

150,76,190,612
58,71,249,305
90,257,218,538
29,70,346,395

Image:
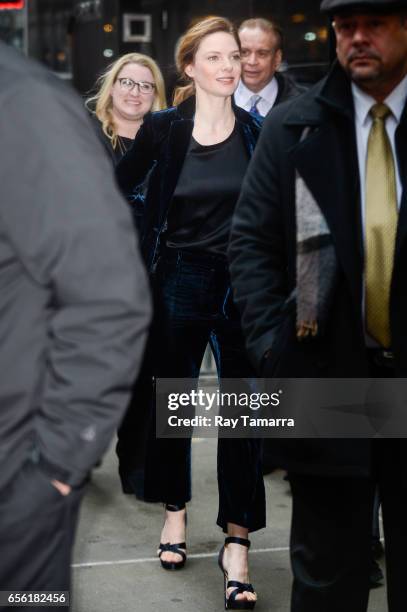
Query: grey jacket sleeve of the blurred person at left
0,77,150,485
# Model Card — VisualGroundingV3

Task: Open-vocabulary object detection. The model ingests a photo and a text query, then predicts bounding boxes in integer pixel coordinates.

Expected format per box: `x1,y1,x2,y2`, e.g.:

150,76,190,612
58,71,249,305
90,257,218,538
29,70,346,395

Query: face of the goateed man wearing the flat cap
334,13,407,100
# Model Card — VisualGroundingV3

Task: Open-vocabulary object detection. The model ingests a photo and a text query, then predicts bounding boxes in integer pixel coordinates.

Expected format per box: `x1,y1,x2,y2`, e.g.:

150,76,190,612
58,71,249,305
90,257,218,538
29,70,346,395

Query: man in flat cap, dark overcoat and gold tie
229,0,407,612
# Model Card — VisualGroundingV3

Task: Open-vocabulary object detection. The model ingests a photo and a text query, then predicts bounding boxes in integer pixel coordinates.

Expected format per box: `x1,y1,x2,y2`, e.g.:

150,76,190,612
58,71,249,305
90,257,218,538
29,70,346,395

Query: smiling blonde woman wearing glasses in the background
86,53,167,164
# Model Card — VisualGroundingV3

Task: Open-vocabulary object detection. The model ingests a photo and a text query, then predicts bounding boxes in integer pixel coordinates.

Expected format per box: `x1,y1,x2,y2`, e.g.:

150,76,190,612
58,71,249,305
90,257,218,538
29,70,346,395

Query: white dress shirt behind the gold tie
352,76,407,346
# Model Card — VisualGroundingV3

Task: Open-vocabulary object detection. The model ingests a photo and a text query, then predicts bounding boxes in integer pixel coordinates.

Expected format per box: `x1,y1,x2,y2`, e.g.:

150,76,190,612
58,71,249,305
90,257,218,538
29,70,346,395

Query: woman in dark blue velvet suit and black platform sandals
117,17,265,609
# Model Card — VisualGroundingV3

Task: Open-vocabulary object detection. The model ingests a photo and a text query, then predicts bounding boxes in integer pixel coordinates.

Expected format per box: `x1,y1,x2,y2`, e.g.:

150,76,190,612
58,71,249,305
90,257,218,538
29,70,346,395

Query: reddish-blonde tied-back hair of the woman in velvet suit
173,15,240,106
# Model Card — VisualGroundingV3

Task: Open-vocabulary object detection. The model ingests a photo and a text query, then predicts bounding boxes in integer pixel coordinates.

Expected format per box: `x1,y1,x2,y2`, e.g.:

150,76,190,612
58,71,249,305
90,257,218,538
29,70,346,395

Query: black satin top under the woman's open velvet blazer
166,126,249,256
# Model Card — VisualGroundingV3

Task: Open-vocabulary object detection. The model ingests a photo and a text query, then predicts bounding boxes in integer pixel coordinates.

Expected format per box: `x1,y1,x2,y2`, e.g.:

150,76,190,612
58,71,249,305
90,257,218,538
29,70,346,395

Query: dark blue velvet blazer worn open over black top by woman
116,97,262,269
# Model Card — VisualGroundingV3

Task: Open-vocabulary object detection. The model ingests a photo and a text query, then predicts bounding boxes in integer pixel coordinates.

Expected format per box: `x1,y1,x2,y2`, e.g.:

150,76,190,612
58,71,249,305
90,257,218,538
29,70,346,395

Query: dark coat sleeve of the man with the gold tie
228,109,287,368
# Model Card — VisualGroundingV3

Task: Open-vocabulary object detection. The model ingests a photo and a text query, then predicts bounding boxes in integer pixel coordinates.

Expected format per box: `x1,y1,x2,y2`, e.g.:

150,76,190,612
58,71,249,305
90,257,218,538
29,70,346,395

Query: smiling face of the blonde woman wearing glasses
111,63,156,121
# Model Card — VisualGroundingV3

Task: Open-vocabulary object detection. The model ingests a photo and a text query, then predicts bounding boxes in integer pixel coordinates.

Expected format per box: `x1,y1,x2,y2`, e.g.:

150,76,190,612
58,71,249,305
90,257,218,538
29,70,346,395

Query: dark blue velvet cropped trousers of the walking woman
144,249,265,531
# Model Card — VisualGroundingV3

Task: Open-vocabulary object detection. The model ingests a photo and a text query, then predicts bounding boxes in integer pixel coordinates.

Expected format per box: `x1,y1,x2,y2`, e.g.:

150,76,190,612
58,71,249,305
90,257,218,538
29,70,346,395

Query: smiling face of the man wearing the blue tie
239,27,282,93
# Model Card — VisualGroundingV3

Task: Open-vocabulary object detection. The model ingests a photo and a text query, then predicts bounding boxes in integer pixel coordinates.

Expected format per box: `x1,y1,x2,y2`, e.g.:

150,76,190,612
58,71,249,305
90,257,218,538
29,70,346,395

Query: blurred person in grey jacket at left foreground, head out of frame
0,43,150,610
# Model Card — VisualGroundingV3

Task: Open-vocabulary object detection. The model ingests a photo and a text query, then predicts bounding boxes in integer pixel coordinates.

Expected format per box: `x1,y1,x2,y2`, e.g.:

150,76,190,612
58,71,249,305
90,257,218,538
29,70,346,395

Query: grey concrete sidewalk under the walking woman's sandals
72,440,387,612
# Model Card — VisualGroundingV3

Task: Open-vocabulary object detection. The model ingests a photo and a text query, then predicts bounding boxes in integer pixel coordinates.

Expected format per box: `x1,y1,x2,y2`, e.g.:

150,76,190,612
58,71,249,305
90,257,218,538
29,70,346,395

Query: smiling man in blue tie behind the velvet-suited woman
235,17,304,117
